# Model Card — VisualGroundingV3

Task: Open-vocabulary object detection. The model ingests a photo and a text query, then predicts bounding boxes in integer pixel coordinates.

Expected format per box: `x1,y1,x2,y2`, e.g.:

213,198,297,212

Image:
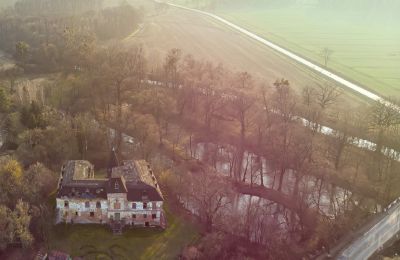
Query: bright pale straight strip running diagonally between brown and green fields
162,1,400,108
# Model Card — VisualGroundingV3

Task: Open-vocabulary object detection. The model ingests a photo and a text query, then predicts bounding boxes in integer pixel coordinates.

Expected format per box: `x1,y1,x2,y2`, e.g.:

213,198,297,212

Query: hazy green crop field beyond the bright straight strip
170,1,400,98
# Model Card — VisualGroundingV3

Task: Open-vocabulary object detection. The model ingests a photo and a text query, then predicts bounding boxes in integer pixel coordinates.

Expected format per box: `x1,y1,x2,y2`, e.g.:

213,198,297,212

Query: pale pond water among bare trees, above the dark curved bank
191,143,376,218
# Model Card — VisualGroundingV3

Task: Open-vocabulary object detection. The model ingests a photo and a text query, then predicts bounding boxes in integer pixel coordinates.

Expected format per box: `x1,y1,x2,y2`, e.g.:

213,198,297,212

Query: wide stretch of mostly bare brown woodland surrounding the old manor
0,0,400,259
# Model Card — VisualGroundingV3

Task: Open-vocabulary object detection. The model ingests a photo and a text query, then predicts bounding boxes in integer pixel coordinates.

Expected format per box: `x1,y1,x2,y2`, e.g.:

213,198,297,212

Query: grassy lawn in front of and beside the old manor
50,205,199,259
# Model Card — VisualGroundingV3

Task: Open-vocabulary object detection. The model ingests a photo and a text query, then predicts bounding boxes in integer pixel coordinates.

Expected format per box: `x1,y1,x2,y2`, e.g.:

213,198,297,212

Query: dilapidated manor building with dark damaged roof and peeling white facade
56,160,165,232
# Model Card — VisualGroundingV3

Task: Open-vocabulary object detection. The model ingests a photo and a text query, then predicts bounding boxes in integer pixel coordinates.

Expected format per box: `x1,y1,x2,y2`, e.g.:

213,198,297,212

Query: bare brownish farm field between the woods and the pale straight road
130,7,365,105
